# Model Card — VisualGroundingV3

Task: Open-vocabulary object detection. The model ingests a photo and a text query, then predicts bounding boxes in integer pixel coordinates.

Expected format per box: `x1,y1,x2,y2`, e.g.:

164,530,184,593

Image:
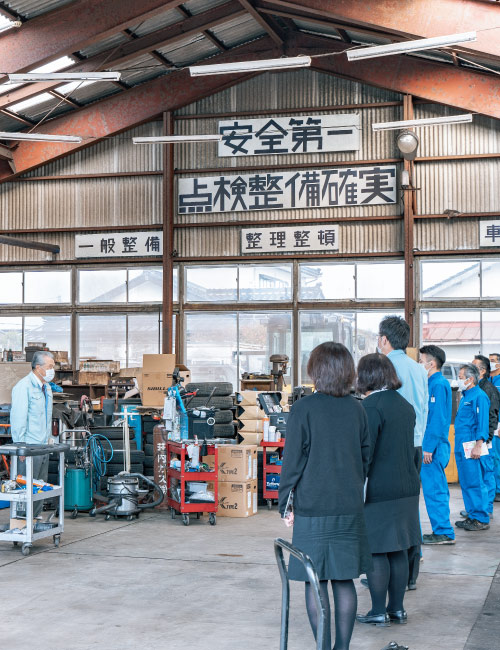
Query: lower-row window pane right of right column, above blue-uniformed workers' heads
422,310,481,362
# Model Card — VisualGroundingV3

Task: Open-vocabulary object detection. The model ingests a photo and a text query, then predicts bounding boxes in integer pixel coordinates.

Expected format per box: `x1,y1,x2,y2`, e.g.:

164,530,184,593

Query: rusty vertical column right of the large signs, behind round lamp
403,95,416,347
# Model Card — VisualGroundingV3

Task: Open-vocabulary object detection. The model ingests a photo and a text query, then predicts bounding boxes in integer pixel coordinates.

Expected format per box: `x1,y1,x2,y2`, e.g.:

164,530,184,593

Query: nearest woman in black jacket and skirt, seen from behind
279,342,371,650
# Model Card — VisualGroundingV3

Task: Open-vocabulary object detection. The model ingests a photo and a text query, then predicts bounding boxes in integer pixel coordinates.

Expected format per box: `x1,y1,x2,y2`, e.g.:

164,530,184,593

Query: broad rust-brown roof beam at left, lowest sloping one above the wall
0,37,279,181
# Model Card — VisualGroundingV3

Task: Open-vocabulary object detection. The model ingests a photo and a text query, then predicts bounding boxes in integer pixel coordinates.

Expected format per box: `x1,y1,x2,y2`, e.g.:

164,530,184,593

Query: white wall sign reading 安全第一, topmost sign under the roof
219,113,360,158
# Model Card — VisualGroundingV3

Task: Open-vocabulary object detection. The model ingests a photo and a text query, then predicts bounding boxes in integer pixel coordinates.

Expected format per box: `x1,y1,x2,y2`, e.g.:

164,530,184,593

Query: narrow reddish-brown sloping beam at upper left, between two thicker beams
0,2,246,110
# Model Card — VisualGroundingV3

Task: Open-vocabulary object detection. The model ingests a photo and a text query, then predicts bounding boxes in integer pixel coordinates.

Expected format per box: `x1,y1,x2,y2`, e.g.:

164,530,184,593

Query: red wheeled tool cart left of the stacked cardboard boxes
167,440,219,526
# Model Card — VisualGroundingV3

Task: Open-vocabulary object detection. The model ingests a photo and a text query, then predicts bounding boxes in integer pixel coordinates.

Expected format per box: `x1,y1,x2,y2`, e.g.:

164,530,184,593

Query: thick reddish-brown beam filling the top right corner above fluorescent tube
260,0,500,57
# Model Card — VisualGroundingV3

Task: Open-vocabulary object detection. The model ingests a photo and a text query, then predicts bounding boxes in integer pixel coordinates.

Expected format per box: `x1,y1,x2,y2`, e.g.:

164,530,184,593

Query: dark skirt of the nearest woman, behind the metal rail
288,512,372,582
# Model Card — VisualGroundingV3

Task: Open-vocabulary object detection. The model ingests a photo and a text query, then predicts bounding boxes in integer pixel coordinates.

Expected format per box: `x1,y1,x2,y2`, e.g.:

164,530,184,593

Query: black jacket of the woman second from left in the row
362,390,420,503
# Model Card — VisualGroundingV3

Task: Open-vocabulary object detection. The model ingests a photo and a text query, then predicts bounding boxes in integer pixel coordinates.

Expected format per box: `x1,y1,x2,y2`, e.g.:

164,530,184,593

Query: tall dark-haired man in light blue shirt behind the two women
378,316,429,589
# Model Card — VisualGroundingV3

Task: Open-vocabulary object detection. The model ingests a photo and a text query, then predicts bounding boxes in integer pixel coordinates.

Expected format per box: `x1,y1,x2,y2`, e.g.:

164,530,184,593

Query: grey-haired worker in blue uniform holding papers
455,363,490,531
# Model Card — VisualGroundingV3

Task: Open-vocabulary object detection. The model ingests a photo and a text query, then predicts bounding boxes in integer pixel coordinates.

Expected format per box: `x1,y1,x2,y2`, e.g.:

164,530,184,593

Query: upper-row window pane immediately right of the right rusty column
420,260,479,300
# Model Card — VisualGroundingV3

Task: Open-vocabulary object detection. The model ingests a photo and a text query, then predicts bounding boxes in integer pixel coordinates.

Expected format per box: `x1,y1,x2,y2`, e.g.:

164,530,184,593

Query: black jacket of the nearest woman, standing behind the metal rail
279,393,370,517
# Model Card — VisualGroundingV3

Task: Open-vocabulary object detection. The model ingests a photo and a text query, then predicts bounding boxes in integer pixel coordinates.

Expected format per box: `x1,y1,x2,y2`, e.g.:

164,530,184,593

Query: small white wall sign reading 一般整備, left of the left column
75,230,163,259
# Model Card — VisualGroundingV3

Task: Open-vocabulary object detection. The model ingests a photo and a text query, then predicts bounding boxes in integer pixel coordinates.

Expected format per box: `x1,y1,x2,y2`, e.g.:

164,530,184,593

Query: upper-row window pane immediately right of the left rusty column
184,266,238,302
